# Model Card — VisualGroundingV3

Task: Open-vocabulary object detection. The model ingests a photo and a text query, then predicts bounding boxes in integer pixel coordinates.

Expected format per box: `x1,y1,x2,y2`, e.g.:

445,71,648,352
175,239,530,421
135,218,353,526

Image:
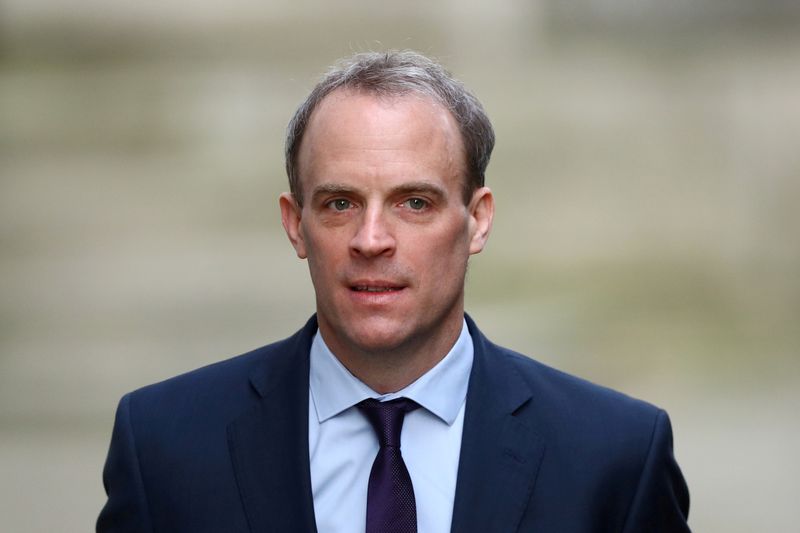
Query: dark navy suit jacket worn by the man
97,317,689,533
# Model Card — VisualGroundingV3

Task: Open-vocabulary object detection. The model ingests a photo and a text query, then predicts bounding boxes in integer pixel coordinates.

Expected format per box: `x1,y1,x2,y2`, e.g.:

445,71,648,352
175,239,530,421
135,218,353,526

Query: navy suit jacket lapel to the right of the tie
451,317,544,533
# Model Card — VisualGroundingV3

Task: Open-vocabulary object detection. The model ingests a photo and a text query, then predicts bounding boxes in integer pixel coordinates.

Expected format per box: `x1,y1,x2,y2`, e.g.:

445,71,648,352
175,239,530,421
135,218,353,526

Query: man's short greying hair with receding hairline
286,50,494,205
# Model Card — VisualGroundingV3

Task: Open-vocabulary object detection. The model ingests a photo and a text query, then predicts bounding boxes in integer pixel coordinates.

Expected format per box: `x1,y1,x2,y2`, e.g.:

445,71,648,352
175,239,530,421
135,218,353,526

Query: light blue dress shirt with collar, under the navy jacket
308,322,473,533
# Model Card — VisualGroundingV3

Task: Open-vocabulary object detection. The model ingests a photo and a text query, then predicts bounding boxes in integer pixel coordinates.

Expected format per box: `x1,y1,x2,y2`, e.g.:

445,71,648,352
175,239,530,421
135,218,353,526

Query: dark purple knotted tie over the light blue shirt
358,398,419,533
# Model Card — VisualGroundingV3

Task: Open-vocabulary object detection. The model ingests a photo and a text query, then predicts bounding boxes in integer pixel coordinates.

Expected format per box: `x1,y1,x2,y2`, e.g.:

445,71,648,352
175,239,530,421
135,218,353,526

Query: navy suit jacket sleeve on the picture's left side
97,394,153,533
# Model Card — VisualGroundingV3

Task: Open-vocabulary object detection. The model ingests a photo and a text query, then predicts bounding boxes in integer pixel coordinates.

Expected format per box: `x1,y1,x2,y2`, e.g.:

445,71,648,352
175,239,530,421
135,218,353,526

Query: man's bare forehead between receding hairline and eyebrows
297,89,466,191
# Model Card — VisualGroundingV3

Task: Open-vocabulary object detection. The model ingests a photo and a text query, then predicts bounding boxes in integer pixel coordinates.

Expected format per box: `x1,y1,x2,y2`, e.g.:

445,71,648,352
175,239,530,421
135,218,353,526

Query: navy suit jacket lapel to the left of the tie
228,319,316,533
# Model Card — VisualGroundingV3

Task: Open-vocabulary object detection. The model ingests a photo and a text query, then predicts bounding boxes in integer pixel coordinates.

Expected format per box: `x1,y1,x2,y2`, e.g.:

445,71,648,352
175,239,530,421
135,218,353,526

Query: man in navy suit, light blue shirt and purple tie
97,52,689,533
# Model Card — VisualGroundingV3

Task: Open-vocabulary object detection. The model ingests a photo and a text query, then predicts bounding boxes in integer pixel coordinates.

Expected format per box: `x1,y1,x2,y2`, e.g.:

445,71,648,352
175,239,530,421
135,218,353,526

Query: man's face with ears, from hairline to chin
281,90,493,357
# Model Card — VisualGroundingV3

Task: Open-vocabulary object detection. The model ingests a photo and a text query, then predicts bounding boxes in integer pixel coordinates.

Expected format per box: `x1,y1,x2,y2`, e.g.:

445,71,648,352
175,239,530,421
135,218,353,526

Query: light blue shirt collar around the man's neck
309,321,473,425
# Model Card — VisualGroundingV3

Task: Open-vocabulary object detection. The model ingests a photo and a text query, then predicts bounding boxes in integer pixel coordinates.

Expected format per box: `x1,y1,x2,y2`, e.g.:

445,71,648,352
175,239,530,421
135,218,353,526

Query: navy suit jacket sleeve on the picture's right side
623,411,690,533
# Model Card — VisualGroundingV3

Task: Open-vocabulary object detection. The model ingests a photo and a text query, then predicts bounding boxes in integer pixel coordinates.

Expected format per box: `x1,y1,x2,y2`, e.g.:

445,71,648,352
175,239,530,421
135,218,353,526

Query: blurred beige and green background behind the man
0,0,800,533
